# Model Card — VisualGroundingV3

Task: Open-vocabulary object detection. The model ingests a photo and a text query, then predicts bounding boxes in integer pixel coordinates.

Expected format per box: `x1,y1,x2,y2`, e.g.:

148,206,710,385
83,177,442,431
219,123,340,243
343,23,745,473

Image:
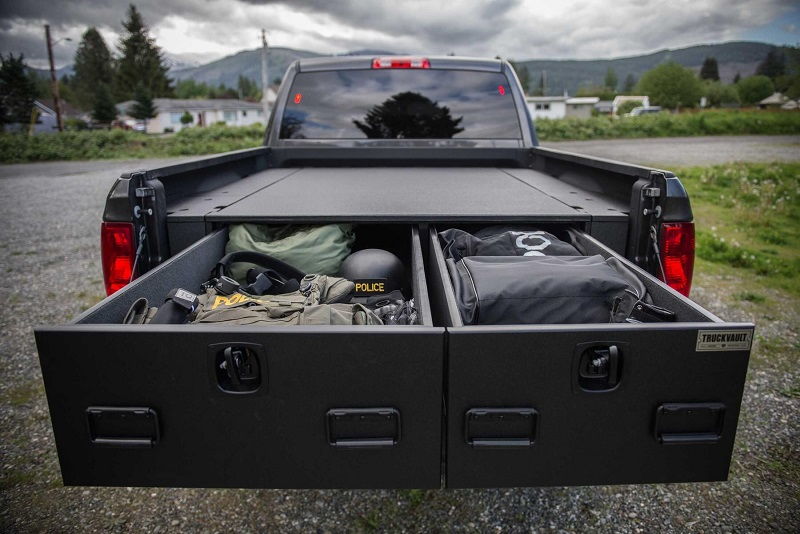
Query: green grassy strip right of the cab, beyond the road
536,110,800,141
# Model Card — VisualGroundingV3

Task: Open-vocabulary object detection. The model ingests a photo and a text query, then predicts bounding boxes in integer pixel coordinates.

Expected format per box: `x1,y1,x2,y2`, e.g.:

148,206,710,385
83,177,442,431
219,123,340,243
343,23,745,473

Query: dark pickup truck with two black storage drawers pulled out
35,57,754,488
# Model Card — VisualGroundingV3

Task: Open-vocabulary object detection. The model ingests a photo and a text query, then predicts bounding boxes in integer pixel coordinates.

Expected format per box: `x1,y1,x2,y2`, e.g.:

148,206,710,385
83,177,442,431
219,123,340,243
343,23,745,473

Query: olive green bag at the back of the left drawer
225,223,356,281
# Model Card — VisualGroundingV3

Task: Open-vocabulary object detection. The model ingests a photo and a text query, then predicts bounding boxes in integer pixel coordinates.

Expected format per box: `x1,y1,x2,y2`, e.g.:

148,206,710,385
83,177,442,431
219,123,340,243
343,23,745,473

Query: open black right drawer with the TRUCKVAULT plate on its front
428,228,753,488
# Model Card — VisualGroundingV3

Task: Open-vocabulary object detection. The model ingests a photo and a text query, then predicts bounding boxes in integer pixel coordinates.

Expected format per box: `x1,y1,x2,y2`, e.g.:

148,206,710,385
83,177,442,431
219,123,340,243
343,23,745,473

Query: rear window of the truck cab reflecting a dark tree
280,69,521,139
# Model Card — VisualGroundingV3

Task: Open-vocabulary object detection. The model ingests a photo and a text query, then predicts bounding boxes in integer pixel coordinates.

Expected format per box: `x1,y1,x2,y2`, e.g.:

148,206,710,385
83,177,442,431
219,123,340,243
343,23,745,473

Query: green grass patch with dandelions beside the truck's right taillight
675,163,800,303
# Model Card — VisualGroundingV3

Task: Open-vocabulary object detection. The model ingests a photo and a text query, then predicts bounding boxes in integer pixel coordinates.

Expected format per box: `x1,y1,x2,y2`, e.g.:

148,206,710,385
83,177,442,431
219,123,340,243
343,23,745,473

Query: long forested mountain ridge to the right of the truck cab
519,41,773,95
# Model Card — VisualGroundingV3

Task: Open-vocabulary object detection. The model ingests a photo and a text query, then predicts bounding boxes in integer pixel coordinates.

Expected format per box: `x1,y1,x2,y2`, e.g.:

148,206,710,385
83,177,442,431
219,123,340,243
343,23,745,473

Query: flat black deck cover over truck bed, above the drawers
168,167,627,223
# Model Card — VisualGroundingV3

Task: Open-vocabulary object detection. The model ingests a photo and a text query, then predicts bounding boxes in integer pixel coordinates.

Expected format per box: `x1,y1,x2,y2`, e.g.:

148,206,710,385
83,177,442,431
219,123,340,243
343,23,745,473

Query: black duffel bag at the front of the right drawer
446,255,674,325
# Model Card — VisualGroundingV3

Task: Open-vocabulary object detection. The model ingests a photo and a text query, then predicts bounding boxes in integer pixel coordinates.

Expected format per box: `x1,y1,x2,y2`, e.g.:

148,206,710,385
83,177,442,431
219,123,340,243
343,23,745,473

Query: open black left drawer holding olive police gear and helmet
36,225,444,488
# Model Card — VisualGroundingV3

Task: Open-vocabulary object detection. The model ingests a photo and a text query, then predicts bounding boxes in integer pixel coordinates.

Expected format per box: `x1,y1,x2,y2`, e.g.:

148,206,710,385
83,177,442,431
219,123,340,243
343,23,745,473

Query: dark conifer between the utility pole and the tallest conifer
71,27,114,111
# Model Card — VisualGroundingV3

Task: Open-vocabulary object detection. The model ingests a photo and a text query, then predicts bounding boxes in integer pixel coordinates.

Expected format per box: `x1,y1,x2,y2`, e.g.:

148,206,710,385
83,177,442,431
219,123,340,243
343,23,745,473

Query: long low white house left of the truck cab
117,98,267,133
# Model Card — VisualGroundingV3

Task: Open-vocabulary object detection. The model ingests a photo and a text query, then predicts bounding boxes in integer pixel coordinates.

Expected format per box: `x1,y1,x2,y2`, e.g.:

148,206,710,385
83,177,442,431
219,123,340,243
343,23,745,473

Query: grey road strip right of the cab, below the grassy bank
542,135,800,167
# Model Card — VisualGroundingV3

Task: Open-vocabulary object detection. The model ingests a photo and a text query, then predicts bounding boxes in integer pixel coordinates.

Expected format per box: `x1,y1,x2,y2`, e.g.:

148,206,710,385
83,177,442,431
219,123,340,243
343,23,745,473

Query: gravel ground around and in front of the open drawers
0,154,800,532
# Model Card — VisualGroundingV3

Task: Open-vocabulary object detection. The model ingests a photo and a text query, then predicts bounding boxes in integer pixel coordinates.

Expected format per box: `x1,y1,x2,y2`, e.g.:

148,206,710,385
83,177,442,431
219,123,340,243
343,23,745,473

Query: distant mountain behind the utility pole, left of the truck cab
169,47,322,87
